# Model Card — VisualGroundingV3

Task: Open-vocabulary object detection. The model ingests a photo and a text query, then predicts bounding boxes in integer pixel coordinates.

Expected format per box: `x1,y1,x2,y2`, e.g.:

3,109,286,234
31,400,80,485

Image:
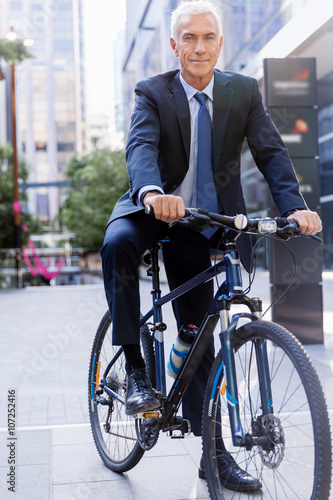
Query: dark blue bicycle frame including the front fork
103,234,273,446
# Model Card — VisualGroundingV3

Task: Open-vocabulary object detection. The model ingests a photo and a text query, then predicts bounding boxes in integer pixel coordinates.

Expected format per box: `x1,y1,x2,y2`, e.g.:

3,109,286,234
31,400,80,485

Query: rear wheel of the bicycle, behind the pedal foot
88,311,155,473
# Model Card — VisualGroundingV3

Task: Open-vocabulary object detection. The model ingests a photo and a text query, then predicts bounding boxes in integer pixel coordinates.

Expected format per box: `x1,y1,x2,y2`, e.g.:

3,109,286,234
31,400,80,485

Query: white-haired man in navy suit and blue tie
101,1,321,491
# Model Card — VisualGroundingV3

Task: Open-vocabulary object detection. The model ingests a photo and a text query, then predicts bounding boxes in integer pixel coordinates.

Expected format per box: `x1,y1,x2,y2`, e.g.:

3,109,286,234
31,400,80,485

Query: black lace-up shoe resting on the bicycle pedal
125,369,160,415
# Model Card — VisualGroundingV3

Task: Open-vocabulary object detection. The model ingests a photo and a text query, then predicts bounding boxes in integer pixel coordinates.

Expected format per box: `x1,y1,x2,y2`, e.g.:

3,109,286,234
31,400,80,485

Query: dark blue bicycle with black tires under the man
89,207,331,500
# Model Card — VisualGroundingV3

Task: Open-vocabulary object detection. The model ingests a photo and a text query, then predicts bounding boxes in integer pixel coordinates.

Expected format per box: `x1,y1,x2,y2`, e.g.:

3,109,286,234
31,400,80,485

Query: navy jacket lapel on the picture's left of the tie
169,73,191,161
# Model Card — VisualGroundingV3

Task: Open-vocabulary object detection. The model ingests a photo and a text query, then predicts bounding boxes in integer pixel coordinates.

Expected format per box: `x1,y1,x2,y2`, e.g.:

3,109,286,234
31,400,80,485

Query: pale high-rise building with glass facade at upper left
0,0,85,222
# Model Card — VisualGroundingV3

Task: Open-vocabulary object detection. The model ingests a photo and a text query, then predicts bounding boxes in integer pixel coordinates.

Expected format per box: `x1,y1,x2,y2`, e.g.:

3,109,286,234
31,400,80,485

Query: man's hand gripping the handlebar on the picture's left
143,191,185,222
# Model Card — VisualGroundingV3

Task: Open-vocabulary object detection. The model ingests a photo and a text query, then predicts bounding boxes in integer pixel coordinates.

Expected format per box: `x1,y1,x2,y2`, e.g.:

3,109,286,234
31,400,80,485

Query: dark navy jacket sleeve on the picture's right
246,79,307,214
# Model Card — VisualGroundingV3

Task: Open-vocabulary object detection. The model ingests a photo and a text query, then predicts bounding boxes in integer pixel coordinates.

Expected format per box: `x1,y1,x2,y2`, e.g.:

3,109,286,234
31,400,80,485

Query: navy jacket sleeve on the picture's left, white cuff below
126,82,163,203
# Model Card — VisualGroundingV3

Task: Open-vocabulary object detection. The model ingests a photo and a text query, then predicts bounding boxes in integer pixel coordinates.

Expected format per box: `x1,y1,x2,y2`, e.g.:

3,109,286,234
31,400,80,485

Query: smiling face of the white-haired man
170,13,223,90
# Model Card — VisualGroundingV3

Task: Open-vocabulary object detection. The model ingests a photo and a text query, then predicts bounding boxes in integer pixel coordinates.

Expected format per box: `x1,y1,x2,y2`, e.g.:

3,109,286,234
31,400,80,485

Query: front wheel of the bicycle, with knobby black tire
202,321,332,500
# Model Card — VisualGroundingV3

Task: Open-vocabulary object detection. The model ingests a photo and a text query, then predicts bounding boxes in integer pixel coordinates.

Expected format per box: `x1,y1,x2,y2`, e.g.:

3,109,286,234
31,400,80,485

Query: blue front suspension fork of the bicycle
216,295,273,449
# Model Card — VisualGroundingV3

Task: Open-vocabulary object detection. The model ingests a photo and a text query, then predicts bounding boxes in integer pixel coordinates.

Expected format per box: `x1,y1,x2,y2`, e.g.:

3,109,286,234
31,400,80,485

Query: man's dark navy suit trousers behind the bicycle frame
101,212,214,436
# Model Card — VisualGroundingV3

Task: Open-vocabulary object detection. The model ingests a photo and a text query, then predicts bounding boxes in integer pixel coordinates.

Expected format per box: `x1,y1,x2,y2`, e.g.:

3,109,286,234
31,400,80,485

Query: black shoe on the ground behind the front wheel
199,452,261,491
